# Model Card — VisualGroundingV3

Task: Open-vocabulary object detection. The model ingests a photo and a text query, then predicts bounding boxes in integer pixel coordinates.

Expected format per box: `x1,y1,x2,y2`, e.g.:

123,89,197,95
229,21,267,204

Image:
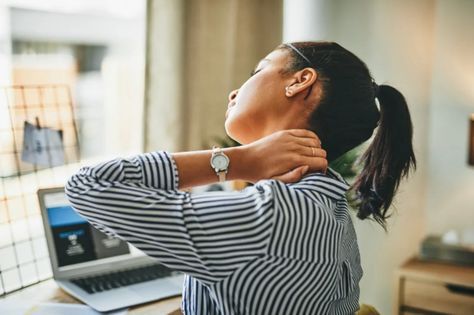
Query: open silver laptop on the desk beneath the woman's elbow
38,187,184,312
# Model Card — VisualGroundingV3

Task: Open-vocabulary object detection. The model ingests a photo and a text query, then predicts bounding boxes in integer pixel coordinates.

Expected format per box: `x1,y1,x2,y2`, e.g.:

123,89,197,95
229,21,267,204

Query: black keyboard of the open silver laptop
71,264,178,294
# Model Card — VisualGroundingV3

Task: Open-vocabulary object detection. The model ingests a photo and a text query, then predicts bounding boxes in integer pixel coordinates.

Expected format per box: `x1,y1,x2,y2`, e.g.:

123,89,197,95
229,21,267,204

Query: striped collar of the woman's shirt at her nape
289,168,350,200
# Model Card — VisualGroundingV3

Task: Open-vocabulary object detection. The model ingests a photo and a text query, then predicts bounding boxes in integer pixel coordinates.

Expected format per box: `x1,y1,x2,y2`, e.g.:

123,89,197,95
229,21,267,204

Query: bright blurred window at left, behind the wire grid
0,0,146,295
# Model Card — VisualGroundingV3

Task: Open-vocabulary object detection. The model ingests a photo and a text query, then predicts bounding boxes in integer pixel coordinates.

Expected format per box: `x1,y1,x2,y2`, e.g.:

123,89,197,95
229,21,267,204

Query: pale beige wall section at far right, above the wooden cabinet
426,0,474,233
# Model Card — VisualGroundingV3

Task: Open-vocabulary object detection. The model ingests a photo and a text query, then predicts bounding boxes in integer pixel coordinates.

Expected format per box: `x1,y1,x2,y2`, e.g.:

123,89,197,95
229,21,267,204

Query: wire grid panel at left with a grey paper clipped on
0,85,80,296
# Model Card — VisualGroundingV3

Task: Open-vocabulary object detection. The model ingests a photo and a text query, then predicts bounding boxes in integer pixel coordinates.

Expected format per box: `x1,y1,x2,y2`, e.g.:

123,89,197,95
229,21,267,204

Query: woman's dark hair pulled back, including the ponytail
277,41,416,229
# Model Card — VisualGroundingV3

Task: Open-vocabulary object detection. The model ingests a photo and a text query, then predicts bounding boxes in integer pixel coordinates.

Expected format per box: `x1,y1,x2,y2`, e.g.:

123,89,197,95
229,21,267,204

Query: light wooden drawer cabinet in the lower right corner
393,258,474,315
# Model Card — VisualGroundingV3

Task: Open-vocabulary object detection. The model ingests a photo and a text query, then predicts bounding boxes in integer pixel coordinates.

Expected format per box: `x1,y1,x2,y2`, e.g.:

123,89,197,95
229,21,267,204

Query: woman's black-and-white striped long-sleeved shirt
66,151,362,315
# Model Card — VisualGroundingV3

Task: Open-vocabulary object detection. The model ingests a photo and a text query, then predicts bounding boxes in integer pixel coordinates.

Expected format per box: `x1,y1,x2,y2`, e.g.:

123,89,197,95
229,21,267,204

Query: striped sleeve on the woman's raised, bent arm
66,151,275,283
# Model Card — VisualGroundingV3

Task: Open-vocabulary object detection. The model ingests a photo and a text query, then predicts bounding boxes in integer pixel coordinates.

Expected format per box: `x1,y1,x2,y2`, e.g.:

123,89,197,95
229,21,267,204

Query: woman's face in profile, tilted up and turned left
225,49,314,144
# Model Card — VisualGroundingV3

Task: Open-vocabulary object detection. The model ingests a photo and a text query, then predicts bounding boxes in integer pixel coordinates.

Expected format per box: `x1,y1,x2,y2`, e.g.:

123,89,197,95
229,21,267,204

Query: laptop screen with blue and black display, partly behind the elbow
42,192,130,267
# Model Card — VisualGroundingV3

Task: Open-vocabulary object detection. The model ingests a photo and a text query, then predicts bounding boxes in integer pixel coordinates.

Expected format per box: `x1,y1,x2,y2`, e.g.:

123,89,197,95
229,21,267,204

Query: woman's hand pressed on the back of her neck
241,129,328,183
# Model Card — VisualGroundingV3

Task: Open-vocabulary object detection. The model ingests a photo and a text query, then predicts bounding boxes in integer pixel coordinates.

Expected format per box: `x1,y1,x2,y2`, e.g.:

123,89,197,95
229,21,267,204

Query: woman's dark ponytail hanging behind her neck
351,85,416,229
